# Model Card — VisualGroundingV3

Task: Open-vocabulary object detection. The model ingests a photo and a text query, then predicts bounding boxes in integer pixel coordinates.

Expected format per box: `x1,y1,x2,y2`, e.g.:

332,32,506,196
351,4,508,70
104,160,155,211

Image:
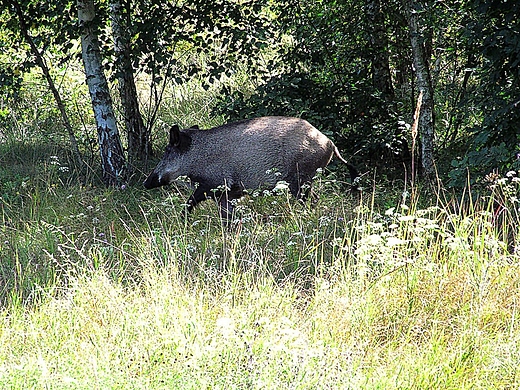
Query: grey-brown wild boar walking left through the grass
144,116,358,220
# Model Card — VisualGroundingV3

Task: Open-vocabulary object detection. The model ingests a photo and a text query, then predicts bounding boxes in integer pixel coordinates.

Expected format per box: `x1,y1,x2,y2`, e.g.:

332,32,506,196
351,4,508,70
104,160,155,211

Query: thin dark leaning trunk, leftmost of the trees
9,0,84,168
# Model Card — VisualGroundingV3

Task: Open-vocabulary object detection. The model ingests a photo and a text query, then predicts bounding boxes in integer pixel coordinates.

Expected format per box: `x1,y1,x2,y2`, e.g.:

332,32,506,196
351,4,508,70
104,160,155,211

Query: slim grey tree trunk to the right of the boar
405,0,435,179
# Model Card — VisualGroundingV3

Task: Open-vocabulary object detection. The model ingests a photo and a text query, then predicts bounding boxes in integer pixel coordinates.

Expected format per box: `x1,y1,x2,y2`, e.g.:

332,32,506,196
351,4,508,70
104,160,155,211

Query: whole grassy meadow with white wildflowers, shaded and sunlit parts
0,77,520,389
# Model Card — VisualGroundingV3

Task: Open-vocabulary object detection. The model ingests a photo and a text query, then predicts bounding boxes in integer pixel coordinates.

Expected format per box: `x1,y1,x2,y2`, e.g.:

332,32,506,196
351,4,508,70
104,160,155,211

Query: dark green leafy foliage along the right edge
450,0,520,186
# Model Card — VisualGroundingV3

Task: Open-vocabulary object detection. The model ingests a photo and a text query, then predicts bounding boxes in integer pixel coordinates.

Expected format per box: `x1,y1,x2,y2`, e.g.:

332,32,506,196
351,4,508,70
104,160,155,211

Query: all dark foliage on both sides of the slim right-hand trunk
214,1,520,188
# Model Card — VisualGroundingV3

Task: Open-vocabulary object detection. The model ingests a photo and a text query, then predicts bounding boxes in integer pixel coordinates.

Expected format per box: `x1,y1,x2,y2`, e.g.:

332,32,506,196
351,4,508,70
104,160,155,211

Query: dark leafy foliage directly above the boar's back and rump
214,1,410,165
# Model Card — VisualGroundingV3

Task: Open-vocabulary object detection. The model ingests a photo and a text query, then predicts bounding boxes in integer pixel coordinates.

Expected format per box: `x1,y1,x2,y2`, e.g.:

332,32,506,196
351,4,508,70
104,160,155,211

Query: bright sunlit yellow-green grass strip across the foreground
0,238,519,389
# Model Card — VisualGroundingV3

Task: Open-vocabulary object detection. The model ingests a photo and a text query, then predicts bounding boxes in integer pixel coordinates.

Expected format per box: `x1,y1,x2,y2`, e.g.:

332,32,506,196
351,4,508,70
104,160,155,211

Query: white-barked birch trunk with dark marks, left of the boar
78,0,126,185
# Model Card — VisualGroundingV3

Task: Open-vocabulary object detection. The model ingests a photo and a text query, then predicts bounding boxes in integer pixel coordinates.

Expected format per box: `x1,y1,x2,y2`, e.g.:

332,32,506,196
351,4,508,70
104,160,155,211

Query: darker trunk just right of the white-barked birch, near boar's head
110,0,152,163
